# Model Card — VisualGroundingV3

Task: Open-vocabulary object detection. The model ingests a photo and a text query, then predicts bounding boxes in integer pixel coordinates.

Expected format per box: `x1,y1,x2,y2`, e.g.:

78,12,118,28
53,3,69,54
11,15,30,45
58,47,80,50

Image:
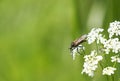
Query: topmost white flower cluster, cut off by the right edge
108,21,120,38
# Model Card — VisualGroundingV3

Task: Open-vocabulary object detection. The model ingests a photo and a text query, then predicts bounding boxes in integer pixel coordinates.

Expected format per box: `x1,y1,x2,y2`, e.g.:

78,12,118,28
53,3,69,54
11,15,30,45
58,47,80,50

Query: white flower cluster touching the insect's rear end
87,28,103,44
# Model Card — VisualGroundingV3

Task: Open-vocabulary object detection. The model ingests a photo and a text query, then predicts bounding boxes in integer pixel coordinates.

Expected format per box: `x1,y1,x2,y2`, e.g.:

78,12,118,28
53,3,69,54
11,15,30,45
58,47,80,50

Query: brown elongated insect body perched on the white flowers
70,35,87,51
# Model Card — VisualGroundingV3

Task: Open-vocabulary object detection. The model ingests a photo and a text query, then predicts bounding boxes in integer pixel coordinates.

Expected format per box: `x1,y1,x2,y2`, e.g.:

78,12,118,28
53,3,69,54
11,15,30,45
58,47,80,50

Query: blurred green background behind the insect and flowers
0,0,120,81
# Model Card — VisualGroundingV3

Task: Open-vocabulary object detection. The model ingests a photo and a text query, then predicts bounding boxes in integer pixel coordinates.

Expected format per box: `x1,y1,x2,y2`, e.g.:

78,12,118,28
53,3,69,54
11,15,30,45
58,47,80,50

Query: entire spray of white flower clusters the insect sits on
72,21,120,77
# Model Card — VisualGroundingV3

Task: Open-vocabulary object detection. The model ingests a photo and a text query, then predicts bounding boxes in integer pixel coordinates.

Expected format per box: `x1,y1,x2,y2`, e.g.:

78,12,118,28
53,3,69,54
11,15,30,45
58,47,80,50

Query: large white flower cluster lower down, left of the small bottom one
81,50,103,77
